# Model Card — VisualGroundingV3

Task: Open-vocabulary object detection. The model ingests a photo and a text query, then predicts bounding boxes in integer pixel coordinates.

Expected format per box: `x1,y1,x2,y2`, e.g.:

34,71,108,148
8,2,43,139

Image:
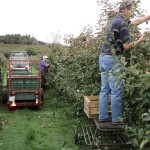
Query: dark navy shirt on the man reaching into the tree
101,15,130,55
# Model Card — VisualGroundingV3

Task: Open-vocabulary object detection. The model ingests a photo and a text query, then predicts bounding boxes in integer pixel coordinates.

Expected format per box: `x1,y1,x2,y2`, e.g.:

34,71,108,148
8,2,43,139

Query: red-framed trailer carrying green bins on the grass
2,59,44,109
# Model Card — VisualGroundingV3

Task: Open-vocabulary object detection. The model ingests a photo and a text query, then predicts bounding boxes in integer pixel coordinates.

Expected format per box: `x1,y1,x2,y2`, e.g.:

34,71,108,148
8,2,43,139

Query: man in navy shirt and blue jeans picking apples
99,1,150,125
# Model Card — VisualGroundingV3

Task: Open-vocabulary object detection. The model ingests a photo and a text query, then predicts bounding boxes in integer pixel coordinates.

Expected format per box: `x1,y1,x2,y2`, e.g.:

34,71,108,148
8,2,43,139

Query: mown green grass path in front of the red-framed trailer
0,90,91,150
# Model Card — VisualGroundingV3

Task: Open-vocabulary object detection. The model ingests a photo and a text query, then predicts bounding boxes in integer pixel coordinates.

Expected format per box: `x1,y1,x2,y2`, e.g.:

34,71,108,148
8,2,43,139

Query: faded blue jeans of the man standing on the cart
99,54,122,122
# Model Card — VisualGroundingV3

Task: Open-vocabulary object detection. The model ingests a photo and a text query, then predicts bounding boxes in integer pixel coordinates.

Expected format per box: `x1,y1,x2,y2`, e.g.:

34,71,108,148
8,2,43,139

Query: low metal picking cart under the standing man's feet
74,118,132,150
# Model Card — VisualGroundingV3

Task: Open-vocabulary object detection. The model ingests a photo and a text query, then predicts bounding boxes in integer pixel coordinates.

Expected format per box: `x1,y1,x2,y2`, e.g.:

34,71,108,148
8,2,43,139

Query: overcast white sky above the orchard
0,0,150,42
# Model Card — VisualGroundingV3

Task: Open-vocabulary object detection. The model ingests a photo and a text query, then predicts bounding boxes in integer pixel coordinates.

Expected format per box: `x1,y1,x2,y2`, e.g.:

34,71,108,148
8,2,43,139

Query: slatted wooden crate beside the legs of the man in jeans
84,96,111,118
